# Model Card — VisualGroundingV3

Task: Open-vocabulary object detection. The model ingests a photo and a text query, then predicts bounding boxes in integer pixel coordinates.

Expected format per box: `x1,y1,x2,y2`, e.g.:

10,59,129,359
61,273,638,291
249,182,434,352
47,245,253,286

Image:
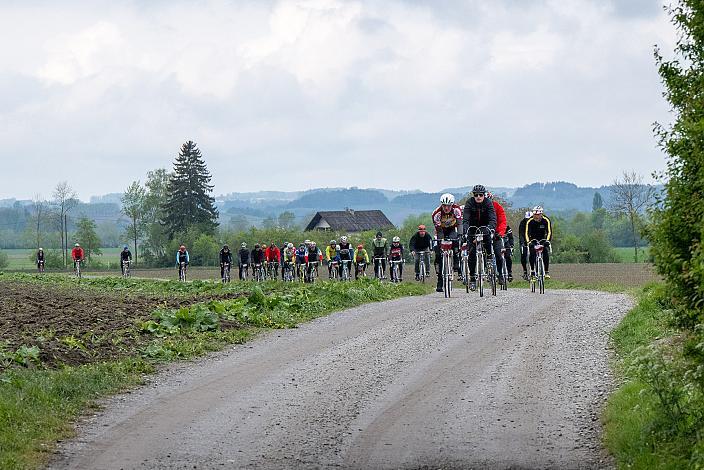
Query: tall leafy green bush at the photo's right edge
649,0,704,328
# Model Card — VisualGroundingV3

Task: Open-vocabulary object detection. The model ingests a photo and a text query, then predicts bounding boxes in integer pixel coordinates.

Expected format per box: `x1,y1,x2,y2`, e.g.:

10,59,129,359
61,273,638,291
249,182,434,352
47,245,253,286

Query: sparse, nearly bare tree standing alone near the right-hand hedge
609,171,655,263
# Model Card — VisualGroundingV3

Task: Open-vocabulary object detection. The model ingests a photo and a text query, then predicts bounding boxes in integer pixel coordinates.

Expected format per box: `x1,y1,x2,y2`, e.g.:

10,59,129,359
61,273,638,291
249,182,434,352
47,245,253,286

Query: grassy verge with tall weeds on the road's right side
604,284,704,469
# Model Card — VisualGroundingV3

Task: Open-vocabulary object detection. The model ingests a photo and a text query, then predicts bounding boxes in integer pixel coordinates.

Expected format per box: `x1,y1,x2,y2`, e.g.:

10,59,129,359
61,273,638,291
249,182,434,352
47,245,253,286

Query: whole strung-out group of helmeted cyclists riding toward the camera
37,184,552,292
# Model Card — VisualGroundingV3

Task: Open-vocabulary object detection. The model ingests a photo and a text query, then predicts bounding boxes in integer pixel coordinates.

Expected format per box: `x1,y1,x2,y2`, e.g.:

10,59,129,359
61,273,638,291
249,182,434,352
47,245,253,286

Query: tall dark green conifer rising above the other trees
162,140,218,238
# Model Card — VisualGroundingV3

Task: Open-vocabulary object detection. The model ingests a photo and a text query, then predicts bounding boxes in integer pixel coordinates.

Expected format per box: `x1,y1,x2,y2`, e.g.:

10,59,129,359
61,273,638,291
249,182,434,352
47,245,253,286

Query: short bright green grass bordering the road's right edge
603,284,692,469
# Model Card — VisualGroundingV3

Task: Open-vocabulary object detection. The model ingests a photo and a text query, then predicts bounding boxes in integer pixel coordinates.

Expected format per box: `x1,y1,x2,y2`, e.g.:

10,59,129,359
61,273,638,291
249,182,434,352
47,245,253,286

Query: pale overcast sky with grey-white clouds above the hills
0,0,675,199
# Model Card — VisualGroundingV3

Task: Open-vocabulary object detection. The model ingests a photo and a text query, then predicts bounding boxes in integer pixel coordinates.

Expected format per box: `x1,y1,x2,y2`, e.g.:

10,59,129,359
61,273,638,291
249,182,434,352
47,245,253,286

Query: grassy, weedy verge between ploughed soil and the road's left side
0,275,432,469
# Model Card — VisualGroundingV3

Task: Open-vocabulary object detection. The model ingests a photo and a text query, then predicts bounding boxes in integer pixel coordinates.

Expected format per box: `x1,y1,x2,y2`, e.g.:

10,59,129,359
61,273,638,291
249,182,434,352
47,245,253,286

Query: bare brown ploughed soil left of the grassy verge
0,281,242,370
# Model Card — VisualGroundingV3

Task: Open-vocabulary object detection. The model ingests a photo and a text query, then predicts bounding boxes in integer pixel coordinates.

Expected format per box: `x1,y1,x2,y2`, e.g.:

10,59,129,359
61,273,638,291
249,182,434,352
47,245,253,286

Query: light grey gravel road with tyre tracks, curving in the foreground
50,290,631,469
